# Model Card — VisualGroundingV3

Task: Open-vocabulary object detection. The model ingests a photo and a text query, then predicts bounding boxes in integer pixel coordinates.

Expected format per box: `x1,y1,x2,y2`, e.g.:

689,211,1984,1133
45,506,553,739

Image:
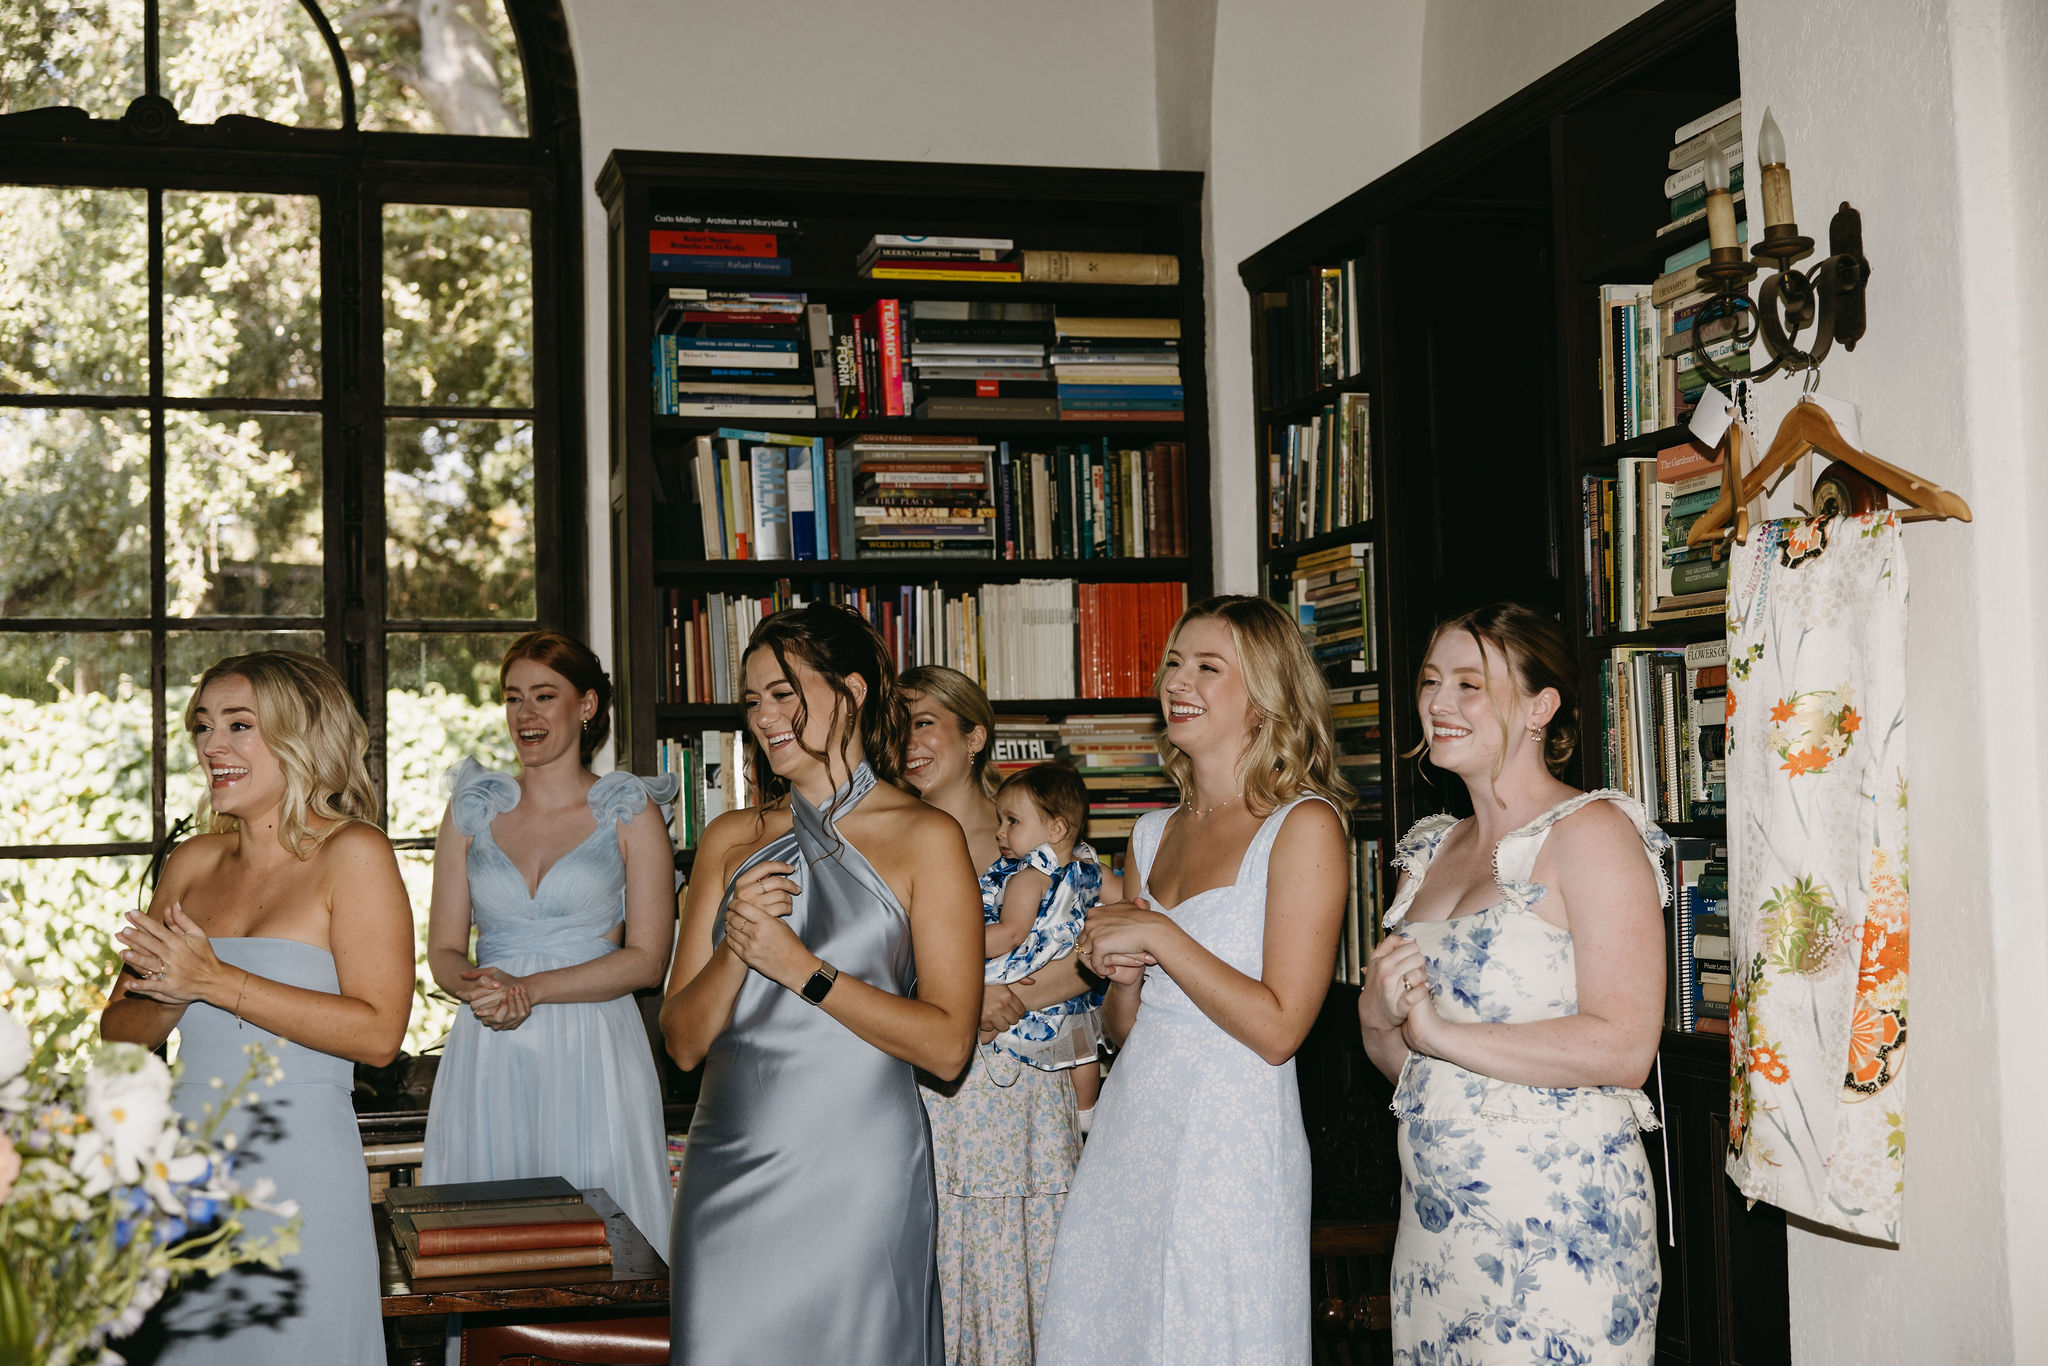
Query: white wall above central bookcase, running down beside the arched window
563,0,1159,684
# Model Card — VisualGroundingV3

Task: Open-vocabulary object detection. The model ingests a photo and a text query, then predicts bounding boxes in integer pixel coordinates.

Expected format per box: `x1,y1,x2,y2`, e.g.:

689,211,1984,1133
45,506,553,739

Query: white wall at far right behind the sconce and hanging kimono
1739,0,2048,1366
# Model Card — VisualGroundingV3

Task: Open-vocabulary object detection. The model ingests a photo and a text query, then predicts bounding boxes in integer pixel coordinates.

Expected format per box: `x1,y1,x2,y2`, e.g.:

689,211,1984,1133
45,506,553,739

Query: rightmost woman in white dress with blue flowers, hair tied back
1358,604,1665,1366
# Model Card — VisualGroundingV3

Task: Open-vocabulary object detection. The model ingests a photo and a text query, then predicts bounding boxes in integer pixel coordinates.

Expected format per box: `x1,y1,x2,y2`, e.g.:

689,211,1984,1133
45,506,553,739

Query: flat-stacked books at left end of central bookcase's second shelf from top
653,287,817,418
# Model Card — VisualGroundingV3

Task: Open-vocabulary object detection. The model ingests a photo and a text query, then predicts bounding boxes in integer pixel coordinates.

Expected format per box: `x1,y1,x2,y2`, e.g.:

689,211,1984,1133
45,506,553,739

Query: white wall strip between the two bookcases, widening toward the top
1208,0,1423,592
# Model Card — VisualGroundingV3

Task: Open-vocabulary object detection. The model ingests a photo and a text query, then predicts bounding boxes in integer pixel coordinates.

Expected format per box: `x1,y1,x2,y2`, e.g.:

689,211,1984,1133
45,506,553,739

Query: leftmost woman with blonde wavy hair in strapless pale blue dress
100,649,412,1366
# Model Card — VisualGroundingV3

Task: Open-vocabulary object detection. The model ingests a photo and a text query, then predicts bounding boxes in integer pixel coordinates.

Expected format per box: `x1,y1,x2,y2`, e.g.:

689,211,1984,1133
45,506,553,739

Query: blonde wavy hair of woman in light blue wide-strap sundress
1153,594,1358,817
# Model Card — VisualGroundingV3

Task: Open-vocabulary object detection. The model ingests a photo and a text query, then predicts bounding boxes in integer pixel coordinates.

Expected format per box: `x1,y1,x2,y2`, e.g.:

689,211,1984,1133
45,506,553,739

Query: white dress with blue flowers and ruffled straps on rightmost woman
1386,791,1667,1366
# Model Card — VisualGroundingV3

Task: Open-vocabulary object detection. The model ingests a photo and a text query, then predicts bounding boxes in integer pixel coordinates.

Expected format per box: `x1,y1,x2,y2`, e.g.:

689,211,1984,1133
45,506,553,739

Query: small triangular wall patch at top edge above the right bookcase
1421,0,1655,145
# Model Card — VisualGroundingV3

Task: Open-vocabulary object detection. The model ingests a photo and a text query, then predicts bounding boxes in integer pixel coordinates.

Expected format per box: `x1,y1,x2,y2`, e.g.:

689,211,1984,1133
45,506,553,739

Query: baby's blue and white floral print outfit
981,844,1102,1073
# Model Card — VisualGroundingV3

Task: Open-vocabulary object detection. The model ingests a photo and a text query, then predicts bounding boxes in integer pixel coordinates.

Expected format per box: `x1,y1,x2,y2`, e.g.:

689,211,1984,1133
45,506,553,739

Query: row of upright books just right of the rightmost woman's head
1599,639,1729,821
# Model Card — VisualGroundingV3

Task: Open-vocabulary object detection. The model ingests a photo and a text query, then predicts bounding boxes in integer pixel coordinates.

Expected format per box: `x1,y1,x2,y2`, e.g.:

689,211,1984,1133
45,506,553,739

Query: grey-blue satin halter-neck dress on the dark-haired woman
670,764,944,1366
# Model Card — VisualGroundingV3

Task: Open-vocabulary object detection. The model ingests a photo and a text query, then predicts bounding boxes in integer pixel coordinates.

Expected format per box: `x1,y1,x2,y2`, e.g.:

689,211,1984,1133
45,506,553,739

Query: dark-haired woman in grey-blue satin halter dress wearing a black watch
662,604,981,1366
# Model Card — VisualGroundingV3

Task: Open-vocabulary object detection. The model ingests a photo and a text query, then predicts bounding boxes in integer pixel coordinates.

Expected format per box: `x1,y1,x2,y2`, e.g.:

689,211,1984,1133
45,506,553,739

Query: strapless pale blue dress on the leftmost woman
149,938,385,1366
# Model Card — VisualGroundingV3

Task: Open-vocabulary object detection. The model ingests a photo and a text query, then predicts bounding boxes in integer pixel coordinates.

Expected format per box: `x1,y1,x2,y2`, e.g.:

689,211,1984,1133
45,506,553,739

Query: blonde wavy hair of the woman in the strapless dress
184,649,377,858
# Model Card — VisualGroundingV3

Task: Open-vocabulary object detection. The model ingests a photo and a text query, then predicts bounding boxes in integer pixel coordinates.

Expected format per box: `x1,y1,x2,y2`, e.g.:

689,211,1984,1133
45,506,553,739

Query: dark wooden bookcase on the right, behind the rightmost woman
1239,0,1790,1366
